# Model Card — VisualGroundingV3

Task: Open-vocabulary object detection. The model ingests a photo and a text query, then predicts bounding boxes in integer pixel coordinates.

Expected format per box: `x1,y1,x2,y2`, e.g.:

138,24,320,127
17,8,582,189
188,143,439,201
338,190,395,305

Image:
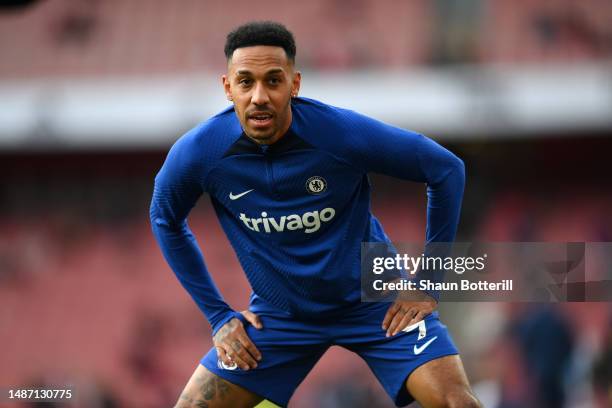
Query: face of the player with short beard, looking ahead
222,45,301,144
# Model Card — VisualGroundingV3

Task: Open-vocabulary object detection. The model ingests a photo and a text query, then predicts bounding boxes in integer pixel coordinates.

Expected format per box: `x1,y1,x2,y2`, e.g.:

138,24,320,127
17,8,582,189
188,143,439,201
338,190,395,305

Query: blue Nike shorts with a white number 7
201,297,458,406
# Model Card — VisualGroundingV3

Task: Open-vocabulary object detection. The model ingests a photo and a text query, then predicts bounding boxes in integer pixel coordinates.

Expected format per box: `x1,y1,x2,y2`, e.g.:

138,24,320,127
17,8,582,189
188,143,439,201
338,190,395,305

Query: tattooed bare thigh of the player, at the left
176,365,263,408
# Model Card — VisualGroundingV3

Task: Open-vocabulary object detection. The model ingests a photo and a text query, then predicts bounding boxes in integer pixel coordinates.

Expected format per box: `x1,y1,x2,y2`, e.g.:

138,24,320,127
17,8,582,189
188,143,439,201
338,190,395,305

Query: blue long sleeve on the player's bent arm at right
338,108,465,300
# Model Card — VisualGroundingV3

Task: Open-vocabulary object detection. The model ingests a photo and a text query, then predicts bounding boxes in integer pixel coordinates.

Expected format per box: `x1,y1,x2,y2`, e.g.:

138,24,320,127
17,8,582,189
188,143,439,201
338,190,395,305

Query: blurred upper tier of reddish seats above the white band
0,0,612,78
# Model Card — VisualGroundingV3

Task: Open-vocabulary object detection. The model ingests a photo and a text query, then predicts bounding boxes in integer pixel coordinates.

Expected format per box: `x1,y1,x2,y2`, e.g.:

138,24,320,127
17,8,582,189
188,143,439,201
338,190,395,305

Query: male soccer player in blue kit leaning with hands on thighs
150,22,479,407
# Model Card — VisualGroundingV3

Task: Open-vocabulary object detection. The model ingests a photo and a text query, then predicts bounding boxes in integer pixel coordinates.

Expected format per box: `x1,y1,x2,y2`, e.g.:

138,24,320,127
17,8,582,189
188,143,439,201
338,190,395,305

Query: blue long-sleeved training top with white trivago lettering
150,98,465,332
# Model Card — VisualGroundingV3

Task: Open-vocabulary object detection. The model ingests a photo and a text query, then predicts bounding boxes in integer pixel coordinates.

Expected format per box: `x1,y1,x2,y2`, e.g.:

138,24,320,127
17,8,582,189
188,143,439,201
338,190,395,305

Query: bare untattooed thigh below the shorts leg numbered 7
406,355,479,408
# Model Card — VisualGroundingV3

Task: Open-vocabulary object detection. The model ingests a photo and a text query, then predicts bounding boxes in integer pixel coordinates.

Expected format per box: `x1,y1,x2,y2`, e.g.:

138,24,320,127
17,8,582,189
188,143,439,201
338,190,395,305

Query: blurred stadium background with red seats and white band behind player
0,0,612,408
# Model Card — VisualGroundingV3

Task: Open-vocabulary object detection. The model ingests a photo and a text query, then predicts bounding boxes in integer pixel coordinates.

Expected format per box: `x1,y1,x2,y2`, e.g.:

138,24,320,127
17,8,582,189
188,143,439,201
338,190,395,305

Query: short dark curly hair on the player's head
224,21,295,62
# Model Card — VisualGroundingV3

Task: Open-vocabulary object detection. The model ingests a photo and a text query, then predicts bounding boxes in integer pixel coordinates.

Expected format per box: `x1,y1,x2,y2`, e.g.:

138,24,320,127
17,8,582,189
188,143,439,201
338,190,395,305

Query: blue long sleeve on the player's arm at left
150,133,237,334
